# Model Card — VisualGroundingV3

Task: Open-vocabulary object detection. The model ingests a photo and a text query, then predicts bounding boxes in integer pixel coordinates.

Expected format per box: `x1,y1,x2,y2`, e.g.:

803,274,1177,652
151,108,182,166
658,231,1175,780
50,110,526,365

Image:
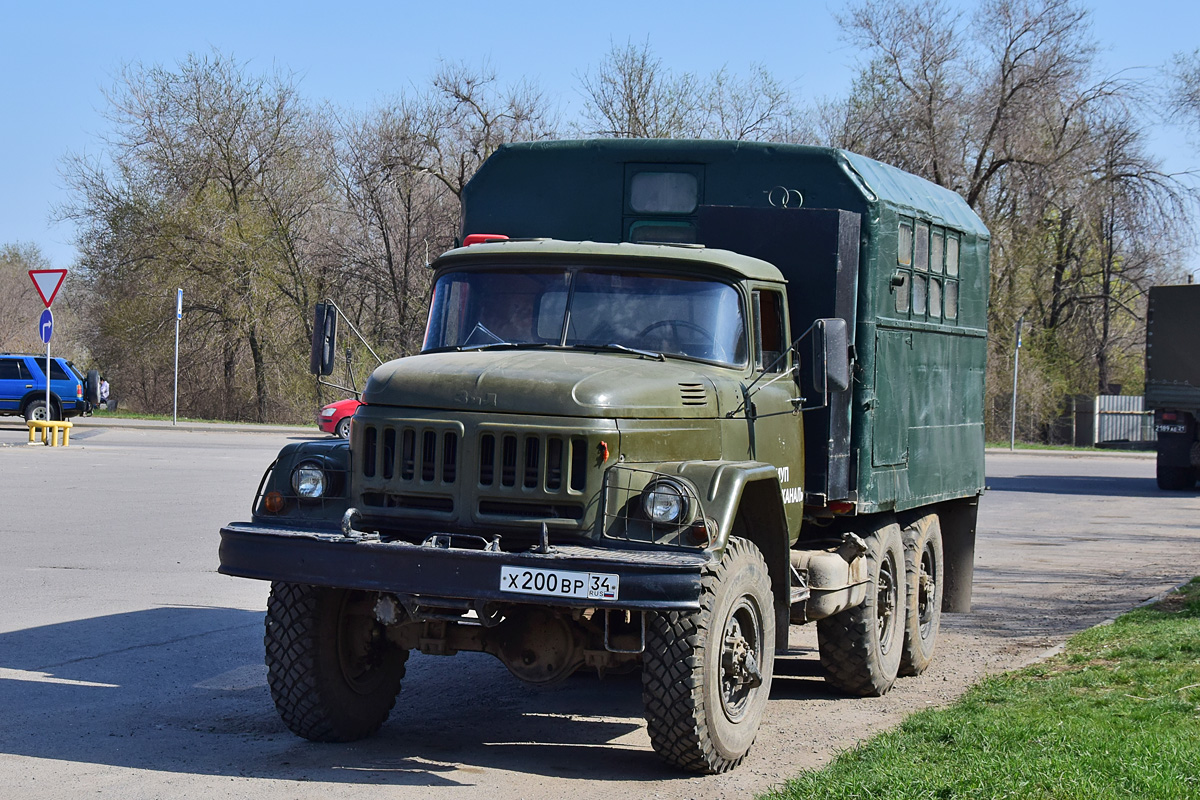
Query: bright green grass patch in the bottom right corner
764,578,1200,800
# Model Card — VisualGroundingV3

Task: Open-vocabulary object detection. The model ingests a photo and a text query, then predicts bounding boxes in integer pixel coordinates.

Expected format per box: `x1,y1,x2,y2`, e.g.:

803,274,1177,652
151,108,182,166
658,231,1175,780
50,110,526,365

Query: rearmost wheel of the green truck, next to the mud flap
900,513,944,675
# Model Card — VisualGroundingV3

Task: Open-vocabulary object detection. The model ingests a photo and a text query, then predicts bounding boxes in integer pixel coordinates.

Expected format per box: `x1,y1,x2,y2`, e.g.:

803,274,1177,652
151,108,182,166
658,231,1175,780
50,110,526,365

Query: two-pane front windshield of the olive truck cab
424,269,746,366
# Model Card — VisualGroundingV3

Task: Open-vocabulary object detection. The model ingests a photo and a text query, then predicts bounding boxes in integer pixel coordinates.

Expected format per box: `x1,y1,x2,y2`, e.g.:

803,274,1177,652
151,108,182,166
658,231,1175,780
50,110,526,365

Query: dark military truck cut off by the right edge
1146,284,1200,491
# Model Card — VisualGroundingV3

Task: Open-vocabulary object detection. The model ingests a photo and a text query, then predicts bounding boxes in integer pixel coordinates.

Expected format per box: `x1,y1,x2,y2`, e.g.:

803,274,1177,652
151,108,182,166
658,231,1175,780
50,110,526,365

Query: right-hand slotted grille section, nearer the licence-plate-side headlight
479,432,588,493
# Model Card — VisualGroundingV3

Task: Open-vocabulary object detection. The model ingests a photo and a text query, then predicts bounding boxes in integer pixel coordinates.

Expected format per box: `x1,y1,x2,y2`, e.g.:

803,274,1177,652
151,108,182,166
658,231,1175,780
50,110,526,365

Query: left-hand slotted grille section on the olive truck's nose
359,425,460,486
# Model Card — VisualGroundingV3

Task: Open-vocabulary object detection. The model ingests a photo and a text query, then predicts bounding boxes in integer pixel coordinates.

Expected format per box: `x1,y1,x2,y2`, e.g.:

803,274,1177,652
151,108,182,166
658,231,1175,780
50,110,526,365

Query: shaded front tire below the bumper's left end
264,582,408,741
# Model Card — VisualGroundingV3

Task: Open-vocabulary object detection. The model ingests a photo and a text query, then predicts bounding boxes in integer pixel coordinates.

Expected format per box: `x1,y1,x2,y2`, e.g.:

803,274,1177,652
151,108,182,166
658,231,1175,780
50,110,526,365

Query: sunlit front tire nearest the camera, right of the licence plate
642,537,775,775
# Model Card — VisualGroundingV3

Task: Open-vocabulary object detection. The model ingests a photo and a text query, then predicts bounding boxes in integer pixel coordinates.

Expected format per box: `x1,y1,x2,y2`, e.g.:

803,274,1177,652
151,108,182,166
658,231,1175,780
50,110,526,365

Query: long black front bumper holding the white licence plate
218,523,712,610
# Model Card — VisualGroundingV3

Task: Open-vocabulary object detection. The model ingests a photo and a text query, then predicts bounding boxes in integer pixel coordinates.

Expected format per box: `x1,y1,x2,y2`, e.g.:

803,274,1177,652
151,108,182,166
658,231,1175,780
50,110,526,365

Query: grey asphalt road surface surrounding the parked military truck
0,420,1200,800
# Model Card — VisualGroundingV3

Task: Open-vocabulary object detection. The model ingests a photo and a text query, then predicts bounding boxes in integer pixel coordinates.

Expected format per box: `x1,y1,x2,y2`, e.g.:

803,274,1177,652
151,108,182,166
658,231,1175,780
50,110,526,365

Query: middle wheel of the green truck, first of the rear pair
817,523,907,697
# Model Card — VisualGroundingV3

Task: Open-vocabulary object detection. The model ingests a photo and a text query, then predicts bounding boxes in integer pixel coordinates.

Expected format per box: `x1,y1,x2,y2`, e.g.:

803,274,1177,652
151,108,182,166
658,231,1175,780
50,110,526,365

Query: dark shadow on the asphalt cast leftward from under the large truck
0,607,739,786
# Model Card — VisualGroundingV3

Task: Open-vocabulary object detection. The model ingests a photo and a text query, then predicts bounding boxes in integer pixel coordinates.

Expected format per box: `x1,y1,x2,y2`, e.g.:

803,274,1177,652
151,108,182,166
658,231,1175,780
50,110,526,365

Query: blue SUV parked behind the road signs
0,353,100,421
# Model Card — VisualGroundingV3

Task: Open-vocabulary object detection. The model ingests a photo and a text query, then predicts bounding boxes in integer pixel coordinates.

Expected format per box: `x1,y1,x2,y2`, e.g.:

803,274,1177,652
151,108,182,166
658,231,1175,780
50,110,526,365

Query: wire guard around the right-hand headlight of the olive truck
604,464,716,548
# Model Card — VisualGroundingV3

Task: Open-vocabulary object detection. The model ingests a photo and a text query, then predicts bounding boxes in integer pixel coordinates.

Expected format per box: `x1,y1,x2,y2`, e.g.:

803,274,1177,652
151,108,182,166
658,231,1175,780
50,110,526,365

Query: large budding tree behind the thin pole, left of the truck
62,53,328,420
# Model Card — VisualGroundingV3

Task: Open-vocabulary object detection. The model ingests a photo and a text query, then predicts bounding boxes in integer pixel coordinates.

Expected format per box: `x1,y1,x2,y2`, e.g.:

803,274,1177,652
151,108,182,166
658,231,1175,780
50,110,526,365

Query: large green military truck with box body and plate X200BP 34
221,140,989,772
